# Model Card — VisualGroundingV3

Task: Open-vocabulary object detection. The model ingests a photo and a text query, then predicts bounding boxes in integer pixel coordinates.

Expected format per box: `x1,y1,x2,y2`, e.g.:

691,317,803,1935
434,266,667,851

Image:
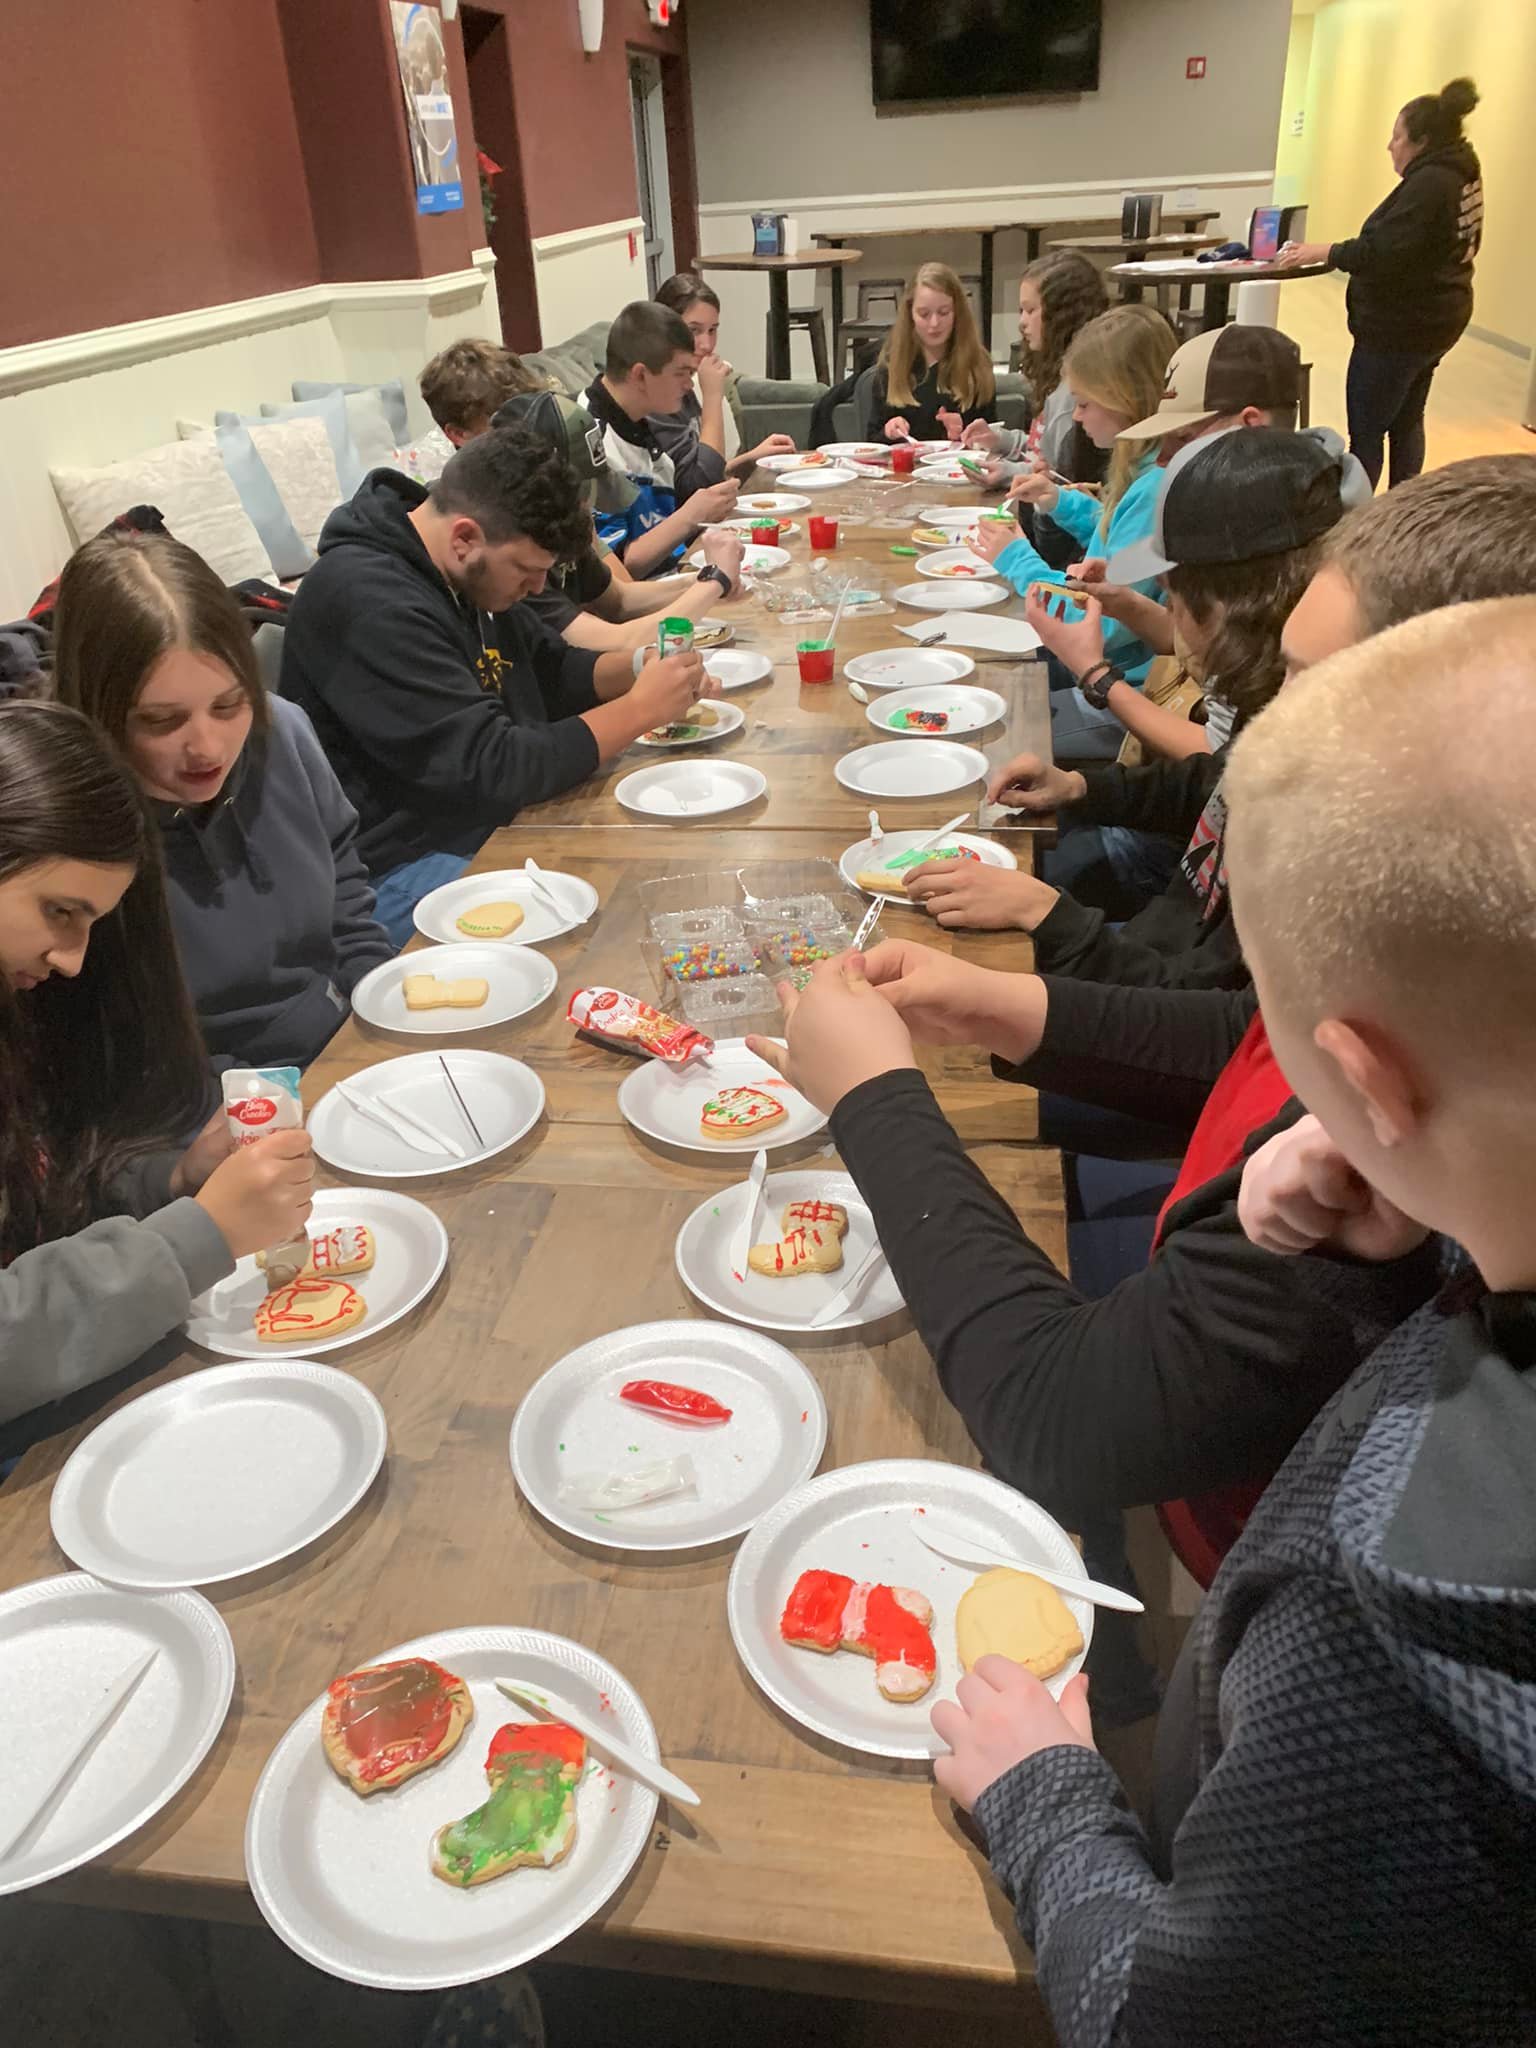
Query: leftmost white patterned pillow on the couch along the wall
49,436,272,584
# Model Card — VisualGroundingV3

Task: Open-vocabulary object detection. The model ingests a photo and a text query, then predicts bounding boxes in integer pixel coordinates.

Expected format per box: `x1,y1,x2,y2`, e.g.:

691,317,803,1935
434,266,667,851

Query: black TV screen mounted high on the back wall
870,0,1100,106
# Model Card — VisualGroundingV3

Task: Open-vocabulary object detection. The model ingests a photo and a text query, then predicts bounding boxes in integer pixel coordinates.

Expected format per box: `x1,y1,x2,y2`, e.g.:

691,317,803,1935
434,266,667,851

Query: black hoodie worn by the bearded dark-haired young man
283,469,598,874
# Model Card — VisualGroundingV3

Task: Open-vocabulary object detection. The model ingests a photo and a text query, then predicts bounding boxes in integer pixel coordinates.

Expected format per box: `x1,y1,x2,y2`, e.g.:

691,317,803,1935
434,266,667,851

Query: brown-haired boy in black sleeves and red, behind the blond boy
754,455,1536,1577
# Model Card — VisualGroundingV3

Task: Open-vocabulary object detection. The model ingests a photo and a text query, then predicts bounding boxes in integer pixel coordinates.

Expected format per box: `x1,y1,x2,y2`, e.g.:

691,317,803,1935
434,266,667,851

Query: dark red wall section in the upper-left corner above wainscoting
0,0,322,346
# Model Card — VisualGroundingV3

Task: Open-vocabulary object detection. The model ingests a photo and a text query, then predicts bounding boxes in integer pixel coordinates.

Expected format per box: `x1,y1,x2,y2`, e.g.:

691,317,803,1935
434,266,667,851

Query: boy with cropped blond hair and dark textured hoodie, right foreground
932,598,1536,2048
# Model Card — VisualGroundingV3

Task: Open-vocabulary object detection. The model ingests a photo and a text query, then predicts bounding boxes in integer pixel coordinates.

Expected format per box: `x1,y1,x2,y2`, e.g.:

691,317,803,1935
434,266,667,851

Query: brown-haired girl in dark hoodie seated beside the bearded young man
55,532,393,1071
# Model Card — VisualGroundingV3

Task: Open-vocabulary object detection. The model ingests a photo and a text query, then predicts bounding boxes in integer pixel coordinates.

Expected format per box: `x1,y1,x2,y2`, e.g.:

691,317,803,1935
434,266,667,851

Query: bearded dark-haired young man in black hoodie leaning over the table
283,432,713,944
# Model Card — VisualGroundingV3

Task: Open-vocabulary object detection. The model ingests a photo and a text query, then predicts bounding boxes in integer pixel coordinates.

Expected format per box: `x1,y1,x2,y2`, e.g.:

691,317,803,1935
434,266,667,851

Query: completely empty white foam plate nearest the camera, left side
49,1358,389,1591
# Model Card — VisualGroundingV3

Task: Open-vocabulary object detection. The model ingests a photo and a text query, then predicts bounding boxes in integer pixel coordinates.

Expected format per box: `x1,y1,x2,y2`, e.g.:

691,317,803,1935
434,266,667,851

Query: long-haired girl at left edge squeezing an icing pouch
0,702,311,1460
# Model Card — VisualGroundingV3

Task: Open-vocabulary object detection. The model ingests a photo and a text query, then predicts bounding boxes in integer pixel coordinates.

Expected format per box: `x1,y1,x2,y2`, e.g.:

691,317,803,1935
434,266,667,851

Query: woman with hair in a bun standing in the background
1278,78,1483,485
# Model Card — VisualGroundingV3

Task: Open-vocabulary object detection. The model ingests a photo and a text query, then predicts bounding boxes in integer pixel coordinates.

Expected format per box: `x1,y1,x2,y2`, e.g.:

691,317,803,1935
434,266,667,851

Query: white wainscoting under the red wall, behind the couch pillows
0,250,500,618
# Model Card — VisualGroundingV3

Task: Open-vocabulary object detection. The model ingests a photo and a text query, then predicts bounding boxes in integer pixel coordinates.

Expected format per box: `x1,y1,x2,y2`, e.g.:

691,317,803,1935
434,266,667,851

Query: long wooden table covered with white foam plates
0,483,1065,2038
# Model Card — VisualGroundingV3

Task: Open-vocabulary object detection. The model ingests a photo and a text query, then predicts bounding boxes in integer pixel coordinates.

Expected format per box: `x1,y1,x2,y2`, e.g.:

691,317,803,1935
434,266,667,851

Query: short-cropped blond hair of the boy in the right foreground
1223,598,1536,1067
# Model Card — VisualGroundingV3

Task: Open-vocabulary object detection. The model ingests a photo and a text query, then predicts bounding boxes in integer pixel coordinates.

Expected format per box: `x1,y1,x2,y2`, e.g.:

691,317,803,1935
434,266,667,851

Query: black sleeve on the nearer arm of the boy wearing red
831,1069,1444,1528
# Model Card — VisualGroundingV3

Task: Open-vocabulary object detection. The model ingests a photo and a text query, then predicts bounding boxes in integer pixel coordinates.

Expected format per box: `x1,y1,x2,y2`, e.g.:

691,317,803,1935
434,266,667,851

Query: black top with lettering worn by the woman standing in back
1329,141,1483,356
